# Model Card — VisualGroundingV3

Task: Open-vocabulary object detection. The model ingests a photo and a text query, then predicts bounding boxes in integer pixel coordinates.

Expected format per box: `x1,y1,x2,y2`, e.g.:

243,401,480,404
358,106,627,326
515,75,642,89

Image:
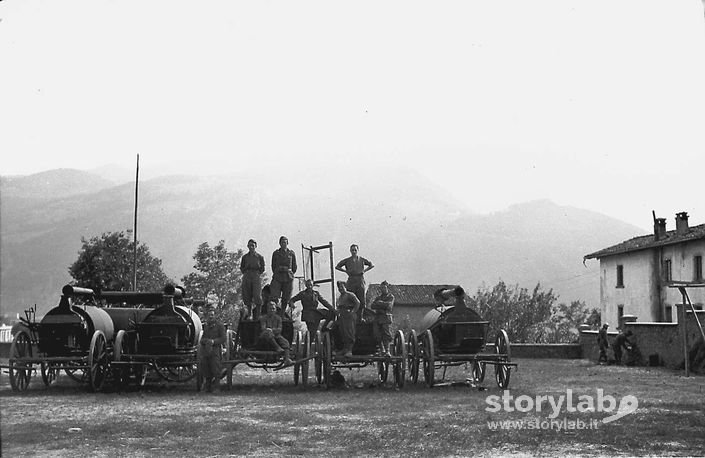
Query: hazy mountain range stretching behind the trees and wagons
0,168,641,317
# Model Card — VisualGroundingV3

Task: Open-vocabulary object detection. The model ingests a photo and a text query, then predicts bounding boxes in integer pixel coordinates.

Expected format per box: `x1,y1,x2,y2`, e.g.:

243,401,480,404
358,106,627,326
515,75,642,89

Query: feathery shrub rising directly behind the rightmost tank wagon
468,281,557,342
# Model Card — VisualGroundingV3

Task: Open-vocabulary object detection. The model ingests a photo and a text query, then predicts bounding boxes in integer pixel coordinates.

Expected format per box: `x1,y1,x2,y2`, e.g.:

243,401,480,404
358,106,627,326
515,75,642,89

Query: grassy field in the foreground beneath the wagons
0,359,705,457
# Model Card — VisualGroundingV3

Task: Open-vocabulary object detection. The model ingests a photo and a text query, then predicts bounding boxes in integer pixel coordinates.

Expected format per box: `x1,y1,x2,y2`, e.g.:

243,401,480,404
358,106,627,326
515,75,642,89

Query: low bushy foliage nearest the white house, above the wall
531,301,600,343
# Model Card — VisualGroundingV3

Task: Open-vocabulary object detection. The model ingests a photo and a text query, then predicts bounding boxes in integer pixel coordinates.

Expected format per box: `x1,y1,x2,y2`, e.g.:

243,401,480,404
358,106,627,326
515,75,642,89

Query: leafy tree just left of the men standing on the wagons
181,240,243,323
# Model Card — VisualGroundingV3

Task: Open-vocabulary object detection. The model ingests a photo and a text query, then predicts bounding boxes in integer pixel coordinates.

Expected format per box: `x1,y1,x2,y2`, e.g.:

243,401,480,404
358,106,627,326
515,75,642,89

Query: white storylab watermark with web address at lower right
485,389,639,430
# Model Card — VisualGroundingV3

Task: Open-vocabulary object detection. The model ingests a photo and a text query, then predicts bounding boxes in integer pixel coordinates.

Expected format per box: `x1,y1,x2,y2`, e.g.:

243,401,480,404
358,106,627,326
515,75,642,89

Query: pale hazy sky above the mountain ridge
0,0,705,230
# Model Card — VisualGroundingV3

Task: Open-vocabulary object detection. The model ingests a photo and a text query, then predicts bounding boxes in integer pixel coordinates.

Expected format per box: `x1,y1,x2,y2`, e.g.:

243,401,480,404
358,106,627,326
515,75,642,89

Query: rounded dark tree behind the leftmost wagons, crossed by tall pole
69,232,173,291
